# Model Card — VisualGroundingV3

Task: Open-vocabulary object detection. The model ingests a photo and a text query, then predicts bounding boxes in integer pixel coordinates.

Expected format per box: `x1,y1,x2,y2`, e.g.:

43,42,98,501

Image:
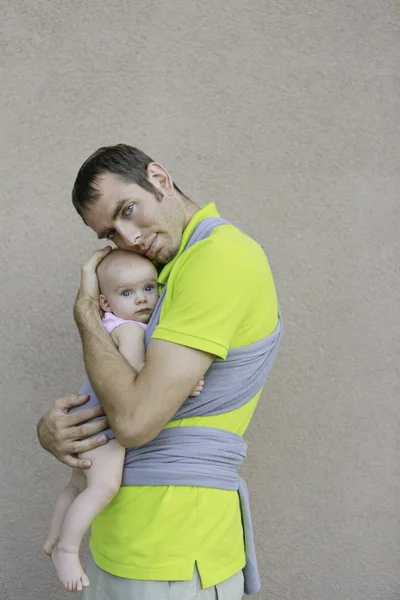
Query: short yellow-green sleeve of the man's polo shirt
152,237,257,359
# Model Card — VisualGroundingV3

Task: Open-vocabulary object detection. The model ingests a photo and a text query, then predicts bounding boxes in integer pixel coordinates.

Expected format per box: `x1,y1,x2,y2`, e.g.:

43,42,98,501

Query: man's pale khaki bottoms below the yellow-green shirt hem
82,557,243,600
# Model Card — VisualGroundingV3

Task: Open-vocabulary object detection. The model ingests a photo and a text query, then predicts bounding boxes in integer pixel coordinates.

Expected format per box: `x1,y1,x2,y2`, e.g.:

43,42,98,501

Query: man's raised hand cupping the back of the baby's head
74,246,112,327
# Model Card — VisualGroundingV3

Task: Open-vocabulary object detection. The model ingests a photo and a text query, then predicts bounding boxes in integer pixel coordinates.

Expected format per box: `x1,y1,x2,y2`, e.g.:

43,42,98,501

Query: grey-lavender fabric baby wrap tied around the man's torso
76,217,282,595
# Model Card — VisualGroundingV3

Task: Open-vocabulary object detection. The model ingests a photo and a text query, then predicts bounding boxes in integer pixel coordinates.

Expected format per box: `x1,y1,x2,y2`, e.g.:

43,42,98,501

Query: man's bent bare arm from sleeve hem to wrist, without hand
77,308,214,447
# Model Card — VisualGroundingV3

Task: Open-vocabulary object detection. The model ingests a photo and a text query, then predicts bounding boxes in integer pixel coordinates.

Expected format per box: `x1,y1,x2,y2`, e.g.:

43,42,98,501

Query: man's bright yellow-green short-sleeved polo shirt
90,203,278,587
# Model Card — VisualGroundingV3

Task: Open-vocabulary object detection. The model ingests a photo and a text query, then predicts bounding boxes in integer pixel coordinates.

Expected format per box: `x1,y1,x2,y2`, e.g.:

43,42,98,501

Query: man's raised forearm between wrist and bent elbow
78,313,137,443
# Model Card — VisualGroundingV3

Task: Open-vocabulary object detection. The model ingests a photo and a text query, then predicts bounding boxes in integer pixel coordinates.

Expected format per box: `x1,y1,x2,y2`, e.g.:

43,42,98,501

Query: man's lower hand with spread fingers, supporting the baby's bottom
37,394,108,469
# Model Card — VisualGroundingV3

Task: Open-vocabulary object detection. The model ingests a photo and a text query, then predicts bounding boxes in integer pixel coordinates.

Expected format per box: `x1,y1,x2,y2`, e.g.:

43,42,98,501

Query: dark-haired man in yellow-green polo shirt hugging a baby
38,144,279,600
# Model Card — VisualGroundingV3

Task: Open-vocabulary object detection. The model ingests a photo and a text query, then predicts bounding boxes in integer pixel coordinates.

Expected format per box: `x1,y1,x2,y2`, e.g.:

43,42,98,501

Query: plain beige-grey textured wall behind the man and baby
0,0,400,600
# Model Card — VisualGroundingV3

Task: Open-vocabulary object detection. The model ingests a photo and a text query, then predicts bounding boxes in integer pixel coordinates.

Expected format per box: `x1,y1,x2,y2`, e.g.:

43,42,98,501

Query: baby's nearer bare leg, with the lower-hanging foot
51,440,125,592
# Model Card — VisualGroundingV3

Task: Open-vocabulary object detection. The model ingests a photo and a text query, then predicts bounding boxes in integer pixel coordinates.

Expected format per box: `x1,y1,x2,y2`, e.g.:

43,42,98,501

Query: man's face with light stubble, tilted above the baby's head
83,173,185,264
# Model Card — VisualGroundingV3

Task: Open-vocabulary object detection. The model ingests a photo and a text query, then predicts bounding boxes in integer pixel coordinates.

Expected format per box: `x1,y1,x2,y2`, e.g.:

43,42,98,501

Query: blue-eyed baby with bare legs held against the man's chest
44,250,204,592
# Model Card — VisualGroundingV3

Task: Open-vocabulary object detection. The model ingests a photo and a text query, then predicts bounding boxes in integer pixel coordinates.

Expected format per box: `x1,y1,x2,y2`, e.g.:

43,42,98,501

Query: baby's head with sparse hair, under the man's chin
97,250,158,323
